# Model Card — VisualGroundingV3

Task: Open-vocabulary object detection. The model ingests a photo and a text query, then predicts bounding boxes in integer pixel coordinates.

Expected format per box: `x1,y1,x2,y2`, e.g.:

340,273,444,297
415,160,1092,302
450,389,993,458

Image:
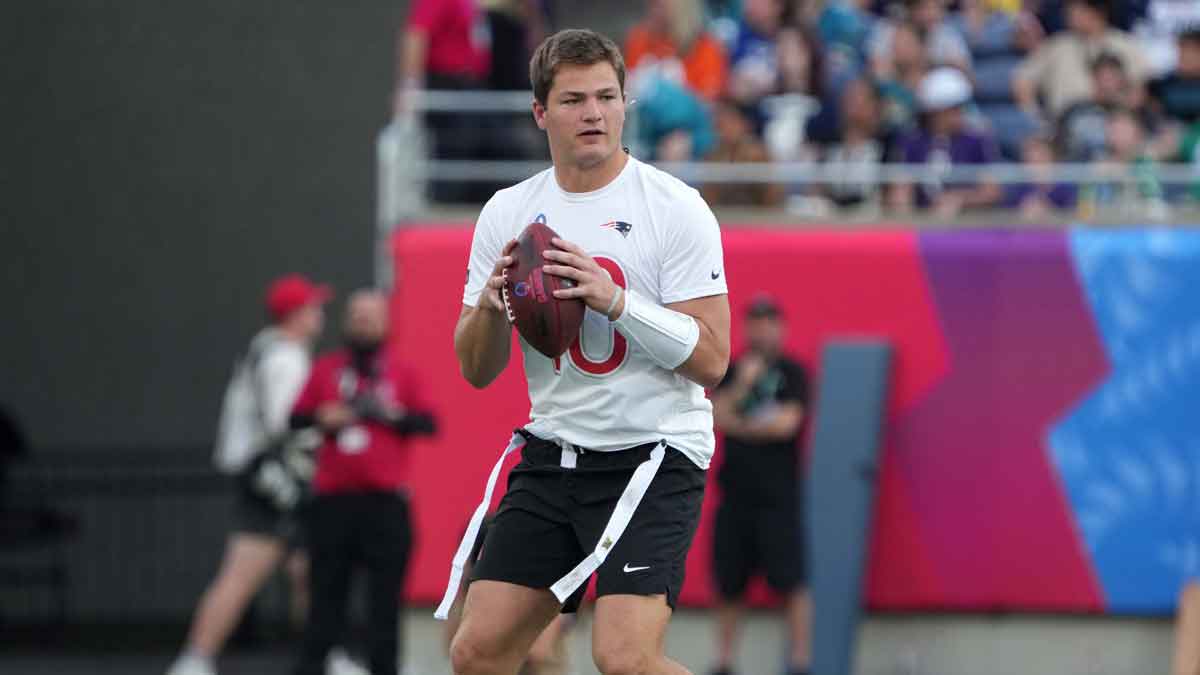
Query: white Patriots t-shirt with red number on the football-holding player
462,157,727,468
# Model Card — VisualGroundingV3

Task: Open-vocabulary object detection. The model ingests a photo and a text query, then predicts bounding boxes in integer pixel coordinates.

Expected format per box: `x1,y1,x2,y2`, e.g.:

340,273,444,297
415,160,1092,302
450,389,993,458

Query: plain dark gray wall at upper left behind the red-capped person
0,0,404,446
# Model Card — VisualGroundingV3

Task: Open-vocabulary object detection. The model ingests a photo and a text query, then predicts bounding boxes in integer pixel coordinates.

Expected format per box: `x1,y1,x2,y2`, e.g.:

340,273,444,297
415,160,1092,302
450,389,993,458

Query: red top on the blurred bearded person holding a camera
293,347,432,495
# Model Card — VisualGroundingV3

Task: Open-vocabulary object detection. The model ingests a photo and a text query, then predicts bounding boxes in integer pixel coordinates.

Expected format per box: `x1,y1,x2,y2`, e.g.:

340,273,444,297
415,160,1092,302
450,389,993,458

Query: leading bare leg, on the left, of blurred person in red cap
187,533,284,657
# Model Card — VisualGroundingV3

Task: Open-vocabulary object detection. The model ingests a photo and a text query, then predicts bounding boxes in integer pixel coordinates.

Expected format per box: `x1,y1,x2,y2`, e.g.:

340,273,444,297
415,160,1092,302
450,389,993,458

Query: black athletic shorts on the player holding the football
472,435,704,613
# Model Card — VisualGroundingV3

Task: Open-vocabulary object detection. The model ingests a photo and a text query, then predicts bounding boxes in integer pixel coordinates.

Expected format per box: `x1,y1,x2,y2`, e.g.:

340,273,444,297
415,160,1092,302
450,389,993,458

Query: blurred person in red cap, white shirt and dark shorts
168,275,348,675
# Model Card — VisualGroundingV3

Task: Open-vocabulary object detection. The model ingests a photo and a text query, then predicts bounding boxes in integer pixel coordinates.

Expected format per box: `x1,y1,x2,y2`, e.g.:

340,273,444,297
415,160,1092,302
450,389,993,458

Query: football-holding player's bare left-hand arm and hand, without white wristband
454,240,517,389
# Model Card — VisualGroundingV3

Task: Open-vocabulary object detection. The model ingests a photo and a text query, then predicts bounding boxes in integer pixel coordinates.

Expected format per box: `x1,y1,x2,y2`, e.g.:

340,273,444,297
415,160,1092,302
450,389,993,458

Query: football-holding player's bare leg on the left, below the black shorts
450,580,559,675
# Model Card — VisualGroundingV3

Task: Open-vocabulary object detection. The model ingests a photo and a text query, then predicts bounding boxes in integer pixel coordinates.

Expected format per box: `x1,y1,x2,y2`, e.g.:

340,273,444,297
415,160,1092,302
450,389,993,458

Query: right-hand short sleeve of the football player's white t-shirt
659,190,728,305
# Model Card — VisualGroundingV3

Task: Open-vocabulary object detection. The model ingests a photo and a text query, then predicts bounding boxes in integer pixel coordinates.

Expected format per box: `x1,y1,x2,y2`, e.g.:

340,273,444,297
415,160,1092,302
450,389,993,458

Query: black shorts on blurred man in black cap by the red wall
713,495,806,599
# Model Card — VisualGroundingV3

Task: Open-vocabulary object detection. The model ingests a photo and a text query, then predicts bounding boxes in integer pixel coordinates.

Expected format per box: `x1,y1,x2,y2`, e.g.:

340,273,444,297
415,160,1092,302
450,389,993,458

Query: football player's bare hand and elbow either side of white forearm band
544,238,730,387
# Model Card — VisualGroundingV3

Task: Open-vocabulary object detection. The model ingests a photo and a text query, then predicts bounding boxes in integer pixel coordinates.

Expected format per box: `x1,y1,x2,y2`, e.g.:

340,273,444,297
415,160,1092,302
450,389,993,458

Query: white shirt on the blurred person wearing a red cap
214,328,311,473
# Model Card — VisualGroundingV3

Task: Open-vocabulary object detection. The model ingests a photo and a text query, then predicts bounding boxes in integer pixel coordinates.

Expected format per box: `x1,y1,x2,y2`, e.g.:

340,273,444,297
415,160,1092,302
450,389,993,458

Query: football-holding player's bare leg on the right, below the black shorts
592,595,690,675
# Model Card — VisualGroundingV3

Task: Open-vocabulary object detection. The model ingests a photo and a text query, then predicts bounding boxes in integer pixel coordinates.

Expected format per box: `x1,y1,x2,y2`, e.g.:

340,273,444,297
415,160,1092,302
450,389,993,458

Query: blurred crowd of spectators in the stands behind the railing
397,0,1200,220
